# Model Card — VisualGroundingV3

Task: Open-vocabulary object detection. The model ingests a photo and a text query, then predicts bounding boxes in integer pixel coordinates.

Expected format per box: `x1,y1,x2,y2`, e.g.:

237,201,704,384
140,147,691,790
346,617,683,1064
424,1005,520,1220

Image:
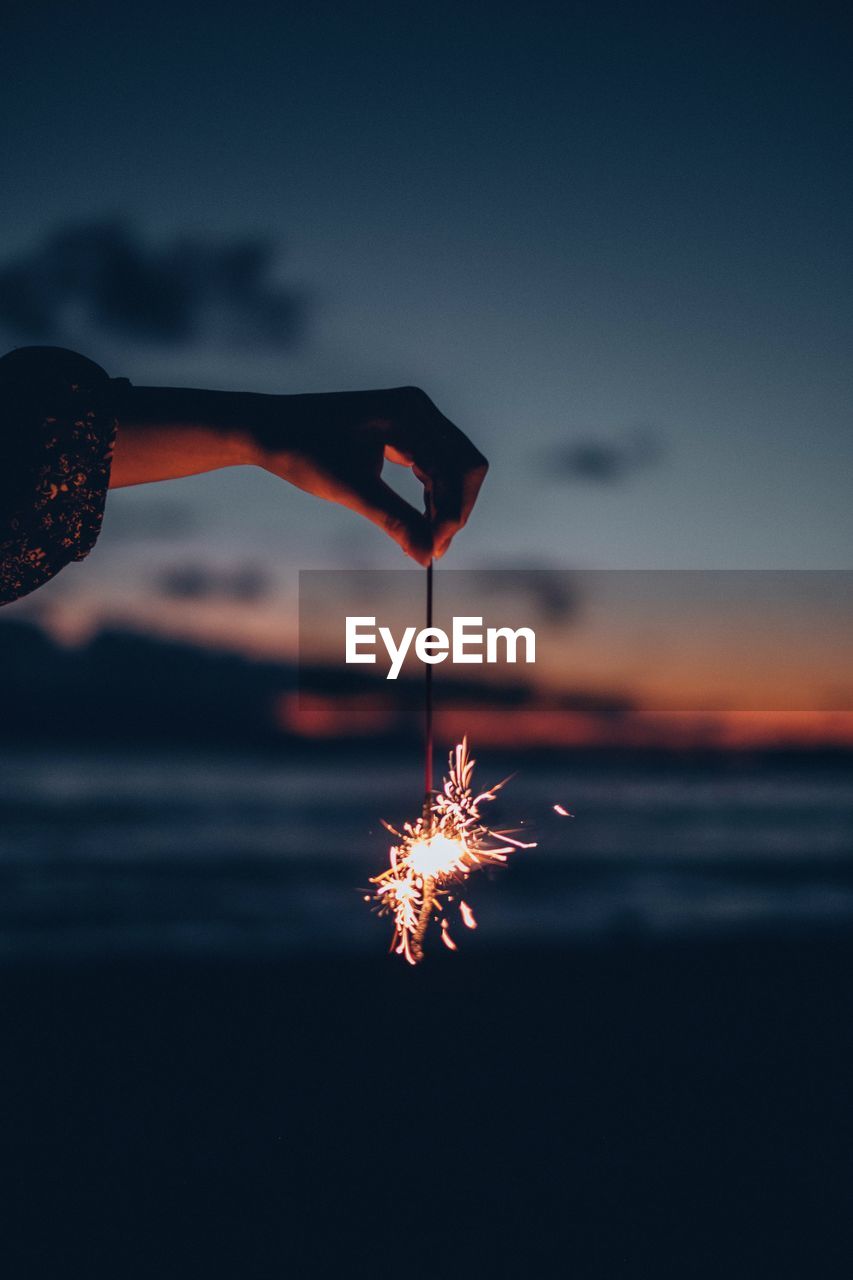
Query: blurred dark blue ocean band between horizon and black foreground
0,749,853,960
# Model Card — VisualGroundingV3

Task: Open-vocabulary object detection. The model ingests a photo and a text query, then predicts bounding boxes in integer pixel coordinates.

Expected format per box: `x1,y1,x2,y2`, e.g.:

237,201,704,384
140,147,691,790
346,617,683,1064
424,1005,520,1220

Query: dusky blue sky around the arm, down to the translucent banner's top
0,0,853,650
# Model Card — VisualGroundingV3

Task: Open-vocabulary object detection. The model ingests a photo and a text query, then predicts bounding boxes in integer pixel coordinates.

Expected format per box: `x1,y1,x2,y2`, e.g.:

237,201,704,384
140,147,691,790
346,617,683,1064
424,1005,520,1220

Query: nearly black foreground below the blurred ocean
0,937,853,1280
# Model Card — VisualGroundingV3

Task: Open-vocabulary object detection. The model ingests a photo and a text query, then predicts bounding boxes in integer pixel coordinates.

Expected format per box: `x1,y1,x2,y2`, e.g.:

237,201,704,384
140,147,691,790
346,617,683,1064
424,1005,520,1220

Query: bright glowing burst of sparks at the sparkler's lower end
371,740,535,964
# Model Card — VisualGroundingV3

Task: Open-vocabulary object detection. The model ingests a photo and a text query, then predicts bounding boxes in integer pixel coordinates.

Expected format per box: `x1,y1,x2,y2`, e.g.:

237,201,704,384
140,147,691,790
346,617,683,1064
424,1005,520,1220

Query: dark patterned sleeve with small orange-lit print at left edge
0,347,128,604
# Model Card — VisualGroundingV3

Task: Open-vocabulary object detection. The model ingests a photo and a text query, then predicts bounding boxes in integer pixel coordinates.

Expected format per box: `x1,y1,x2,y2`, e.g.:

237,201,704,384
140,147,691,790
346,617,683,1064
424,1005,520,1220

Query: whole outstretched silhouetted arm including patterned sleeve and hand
0,347,487,603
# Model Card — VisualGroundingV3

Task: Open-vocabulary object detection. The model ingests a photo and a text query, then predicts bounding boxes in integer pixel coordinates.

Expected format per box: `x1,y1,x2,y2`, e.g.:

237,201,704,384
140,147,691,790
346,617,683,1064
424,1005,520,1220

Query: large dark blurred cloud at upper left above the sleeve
0,221,305,348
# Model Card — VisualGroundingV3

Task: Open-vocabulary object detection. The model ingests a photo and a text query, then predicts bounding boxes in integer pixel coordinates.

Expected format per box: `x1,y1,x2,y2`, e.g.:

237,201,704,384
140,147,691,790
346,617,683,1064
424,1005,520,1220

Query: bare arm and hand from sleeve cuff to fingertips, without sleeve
110,387,488,564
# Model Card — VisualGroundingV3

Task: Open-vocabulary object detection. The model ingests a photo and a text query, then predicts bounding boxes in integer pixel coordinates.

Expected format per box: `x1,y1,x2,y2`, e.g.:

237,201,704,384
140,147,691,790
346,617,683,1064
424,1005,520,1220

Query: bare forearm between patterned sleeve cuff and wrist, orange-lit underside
110,387,272,489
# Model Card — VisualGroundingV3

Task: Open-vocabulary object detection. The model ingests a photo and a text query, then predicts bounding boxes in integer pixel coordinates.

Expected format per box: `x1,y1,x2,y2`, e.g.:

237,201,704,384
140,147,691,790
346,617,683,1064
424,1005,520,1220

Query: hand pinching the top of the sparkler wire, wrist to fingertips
259,387,488,564
